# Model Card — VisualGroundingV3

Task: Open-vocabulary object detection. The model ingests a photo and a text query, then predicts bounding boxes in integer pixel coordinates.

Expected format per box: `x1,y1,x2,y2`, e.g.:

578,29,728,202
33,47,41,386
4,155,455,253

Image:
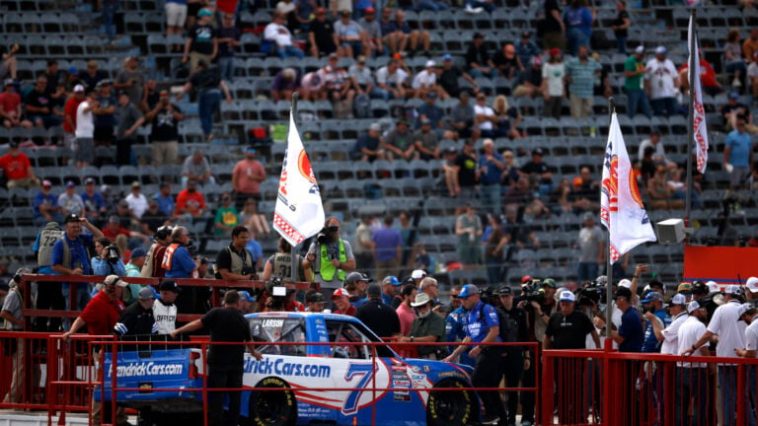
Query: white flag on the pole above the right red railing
600,112,656,263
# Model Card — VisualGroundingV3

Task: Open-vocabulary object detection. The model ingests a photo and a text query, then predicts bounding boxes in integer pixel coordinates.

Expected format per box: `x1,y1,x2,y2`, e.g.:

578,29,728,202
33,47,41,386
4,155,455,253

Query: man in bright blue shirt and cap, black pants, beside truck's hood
445,284,506,424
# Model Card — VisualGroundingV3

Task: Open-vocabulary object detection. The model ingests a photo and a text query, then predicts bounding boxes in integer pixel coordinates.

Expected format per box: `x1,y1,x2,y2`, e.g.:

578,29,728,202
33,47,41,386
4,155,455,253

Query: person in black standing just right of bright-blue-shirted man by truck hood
497,284,536,425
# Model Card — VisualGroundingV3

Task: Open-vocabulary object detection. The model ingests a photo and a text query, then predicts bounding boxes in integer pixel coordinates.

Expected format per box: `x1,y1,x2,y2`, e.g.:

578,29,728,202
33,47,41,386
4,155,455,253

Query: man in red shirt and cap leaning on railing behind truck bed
63,275,129,340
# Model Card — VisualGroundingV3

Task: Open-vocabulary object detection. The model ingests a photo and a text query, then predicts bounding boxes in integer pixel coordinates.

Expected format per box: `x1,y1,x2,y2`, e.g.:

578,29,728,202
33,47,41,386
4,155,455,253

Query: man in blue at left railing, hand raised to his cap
50,214,104,316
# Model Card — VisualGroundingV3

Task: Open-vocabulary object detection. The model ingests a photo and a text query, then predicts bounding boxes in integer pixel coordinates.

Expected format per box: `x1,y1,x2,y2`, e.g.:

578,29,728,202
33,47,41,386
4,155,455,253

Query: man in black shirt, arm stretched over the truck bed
171,290,263,426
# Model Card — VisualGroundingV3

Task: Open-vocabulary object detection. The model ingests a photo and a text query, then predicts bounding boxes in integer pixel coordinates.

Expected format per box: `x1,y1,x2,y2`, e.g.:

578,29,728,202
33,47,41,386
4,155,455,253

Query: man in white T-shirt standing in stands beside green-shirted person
645,46,679,117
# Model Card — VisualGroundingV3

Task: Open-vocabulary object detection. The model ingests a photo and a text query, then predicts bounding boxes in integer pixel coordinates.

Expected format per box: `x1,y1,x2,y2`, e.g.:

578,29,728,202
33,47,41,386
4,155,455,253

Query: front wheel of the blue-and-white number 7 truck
426,380,479,426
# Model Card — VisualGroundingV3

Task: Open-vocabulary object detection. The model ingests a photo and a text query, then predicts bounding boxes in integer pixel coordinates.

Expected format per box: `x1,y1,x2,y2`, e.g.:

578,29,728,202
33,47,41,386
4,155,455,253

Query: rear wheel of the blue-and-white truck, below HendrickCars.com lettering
250,377,297,426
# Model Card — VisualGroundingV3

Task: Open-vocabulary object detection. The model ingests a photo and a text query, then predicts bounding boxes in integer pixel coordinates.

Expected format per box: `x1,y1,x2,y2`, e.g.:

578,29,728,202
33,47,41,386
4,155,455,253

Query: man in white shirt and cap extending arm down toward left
684,285,746,425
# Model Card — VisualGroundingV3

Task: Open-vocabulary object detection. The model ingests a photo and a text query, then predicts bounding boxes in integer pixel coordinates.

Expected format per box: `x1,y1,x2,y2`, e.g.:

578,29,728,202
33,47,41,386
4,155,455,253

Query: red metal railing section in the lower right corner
541,342,758,426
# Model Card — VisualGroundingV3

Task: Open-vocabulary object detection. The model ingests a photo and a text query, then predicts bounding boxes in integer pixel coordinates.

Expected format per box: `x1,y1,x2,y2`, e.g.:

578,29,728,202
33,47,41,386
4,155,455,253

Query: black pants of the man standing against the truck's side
208,364,242,426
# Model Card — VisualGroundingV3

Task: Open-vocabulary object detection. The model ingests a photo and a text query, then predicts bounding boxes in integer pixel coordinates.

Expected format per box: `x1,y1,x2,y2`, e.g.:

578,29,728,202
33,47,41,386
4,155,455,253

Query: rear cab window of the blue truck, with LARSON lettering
249,317,306,356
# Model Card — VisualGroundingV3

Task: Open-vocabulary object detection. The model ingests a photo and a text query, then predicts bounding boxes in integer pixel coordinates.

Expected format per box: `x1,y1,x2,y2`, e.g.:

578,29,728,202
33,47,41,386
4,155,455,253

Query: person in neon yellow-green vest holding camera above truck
303,217,355,296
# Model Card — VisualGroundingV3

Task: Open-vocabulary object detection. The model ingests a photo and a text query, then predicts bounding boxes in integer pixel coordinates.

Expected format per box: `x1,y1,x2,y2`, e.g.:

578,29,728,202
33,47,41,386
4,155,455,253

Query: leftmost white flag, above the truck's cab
274,111,325,246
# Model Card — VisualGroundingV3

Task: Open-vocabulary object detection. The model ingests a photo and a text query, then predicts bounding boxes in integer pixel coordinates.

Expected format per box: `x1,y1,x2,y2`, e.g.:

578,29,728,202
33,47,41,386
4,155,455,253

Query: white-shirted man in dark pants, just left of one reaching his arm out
674,300,715,425
